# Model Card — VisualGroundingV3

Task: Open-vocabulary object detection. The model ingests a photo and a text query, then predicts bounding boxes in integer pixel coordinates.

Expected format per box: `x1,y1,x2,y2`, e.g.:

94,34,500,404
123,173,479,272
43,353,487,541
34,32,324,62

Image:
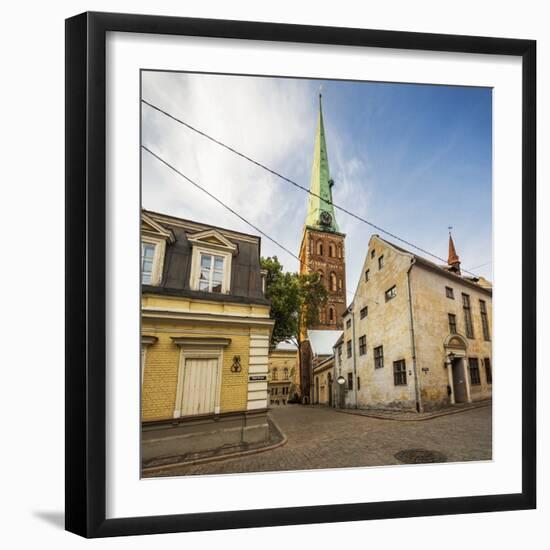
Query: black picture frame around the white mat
65,13,536,537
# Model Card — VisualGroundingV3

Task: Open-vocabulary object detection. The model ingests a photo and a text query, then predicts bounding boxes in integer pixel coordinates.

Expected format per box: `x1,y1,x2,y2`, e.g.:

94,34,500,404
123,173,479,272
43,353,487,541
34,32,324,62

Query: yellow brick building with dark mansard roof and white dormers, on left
141,211,274,465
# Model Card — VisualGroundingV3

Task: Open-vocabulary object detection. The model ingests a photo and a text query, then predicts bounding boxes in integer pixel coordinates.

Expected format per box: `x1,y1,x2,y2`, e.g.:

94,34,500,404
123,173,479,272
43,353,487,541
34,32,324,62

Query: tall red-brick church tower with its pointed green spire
300,94,346,330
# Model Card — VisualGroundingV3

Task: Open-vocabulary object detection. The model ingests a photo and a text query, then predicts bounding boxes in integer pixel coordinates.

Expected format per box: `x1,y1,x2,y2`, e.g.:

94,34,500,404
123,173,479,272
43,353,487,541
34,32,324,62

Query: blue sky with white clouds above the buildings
142,71,492,301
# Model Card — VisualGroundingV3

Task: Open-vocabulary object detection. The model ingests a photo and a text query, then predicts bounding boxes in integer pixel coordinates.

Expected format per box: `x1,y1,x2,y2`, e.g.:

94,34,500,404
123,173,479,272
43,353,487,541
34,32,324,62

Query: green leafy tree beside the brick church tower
260,256,328,347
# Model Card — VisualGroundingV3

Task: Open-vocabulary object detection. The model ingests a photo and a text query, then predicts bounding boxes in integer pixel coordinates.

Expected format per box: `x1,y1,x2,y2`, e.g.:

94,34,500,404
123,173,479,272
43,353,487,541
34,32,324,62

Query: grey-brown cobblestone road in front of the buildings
150,405,492,475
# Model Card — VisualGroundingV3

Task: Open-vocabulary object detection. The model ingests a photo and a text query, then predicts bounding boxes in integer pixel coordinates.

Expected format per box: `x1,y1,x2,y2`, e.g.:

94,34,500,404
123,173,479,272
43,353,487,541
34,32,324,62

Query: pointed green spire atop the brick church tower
306,94,340,233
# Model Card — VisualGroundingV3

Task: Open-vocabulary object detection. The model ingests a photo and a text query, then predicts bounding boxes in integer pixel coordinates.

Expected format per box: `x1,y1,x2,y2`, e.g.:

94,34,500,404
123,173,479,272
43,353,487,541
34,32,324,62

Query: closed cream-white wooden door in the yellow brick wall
181,359,222,416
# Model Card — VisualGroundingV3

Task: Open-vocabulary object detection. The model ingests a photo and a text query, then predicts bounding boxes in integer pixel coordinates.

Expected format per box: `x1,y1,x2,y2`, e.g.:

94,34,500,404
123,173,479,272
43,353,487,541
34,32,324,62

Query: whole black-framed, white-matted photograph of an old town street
66,13,536,537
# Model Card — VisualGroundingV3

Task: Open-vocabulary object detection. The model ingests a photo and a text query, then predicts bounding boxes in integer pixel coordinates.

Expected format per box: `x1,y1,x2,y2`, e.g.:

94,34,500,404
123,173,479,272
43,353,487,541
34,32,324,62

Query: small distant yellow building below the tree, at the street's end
268,342,300,405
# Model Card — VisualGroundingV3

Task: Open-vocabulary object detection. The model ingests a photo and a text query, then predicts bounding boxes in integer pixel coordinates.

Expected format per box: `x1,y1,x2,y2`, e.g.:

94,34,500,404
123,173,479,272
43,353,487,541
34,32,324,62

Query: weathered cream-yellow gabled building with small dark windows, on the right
335,235,493,411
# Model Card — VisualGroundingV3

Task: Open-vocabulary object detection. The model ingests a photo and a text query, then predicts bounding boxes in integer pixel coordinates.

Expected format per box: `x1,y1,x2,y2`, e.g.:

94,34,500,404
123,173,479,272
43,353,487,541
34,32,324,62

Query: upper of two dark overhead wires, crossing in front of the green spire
141,99,488,278
